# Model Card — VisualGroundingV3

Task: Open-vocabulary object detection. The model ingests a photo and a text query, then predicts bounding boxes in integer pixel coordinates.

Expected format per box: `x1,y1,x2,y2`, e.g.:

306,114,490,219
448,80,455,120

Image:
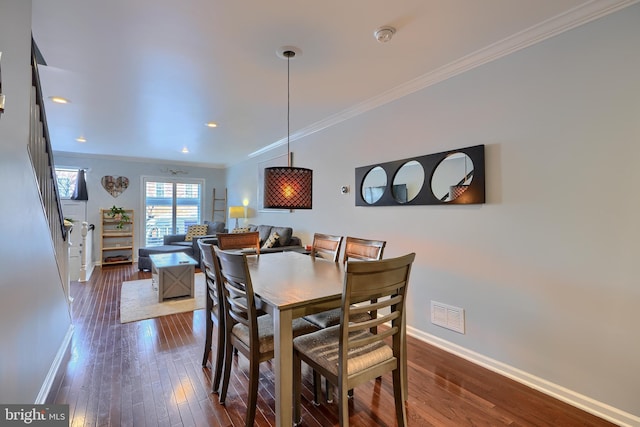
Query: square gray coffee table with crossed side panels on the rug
149,252,198,302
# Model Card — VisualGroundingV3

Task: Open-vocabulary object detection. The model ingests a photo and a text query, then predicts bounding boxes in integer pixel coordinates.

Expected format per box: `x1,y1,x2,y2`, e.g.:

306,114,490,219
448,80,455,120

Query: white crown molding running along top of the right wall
249,0,640,157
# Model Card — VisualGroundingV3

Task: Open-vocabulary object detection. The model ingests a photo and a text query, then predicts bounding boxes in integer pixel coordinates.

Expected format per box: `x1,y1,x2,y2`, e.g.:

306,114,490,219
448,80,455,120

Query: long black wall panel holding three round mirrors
355,145,485,206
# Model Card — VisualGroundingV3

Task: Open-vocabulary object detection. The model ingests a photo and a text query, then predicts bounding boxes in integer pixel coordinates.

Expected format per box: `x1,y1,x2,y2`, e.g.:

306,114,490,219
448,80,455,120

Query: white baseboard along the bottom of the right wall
407,326,640,427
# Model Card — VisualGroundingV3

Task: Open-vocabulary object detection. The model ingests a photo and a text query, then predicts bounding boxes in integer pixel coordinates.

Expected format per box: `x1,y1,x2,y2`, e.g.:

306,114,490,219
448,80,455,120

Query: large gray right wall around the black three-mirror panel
227,5,640,425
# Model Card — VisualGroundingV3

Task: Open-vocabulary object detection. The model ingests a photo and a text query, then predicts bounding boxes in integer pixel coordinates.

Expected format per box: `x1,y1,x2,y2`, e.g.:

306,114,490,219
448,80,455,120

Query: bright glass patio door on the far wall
143,178,204,246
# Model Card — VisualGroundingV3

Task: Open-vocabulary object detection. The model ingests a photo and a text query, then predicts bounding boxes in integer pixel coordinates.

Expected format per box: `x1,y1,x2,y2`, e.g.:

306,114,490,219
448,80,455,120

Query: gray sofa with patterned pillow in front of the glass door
138,221,225,271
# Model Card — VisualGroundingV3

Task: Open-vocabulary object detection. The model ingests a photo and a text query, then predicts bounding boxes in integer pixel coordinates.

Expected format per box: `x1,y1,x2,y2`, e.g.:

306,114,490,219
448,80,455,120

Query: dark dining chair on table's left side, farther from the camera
198,240,225,393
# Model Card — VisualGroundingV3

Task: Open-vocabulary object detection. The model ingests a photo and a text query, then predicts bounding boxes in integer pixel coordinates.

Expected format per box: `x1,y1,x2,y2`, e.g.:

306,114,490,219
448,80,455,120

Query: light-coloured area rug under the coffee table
120,273,206,323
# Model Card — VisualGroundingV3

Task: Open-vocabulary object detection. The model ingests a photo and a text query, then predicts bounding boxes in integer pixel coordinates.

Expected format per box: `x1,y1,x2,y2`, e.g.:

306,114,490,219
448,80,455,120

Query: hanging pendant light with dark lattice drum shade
264,48,313,209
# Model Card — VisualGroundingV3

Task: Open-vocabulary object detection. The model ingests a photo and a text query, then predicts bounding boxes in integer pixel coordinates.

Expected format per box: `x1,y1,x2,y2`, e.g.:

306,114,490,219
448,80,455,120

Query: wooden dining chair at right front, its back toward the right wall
293,253,415,426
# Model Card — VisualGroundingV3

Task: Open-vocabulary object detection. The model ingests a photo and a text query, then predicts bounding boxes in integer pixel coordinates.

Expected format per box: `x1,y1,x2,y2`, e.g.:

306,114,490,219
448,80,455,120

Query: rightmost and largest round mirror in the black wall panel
431,153,473,202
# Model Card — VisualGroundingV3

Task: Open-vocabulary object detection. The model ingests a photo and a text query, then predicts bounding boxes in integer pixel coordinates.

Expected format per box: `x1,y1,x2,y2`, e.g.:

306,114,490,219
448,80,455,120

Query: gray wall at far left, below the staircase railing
0,0,71,404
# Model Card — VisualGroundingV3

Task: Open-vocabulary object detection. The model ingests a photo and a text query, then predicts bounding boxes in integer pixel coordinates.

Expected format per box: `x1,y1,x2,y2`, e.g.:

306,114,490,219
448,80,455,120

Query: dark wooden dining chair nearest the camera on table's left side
215,248,318,426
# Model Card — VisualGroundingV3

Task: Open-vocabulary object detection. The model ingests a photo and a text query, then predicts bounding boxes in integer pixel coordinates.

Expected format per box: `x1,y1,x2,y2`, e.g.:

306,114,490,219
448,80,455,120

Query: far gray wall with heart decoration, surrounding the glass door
54,153,228,264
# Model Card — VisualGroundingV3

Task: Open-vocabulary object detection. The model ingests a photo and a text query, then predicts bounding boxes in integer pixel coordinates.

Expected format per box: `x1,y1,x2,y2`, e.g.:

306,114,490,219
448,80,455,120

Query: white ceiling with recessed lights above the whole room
33,0,635,167
